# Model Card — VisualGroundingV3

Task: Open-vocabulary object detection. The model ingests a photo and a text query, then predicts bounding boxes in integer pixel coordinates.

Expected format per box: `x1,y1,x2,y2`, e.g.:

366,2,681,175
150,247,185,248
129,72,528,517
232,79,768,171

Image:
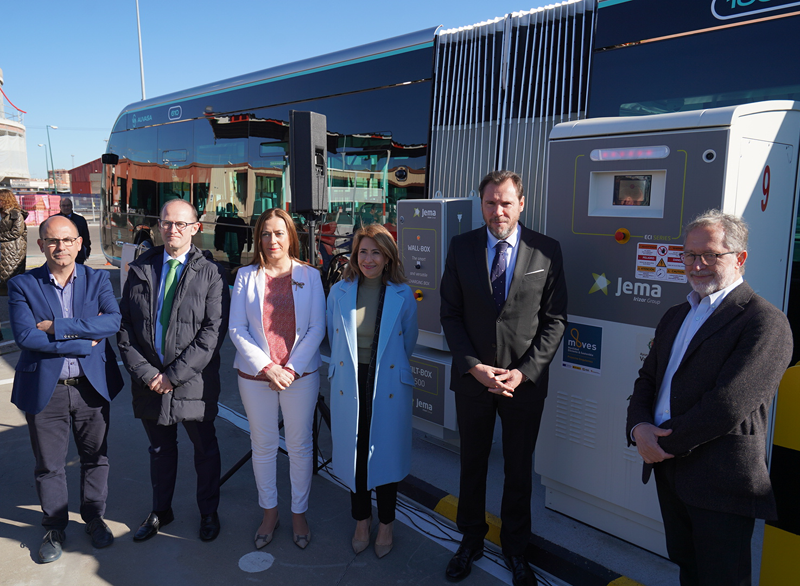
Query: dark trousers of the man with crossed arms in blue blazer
25,379,109,531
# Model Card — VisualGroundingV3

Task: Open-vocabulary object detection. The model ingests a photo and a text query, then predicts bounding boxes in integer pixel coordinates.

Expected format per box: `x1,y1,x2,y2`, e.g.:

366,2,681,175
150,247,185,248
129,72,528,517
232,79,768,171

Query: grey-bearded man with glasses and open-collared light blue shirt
627,210,792,586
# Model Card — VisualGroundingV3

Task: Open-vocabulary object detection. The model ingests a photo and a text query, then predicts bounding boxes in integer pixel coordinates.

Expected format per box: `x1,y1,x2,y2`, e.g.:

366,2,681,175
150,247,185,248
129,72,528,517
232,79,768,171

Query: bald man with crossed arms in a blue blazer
8,216,123,563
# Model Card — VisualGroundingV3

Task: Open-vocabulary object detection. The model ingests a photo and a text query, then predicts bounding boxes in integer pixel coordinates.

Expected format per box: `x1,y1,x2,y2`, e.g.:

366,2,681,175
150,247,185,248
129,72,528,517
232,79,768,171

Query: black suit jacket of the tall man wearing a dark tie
441,224,567,400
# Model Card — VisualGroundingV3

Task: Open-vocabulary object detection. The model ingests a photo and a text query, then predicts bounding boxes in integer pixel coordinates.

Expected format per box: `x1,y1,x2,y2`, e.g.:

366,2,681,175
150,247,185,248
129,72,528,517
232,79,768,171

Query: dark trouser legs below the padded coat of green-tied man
142,419,222,515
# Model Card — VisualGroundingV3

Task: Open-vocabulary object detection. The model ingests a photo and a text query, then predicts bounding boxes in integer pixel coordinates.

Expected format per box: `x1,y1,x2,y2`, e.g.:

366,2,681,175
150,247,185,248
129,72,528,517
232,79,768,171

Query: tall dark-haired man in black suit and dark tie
441,171,567,585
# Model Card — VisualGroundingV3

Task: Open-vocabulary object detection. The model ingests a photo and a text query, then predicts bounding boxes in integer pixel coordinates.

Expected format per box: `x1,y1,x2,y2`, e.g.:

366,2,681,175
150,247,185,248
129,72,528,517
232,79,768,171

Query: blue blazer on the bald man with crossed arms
8,264,124,414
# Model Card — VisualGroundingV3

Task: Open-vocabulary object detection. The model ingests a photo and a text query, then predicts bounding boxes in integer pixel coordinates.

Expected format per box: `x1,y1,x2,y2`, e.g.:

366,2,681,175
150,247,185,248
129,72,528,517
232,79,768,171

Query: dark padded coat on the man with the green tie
117,245,230,425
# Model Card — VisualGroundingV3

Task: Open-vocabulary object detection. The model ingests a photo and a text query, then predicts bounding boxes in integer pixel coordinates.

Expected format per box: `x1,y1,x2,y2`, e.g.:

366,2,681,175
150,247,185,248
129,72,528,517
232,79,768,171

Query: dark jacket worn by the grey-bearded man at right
627,283,792,519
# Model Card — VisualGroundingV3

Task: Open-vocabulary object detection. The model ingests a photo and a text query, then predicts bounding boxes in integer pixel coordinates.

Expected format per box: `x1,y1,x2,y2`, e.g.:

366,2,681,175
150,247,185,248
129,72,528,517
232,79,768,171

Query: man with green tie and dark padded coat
117,199,230,541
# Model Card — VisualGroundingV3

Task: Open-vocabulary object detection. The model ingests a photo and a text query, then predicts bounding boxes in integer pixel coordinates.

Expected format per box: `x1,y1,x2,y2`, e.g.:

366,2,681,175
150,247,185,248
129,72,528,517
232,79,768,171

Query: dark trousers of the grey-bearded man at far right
654,460,755,586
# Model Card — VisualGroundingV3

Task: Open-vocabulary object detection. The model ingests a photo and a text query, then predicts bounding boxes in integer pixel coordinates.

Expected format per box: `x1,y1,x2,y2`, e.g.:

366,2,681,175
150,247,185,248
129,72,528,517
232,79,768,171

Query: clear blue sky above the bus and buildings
0,0,554,178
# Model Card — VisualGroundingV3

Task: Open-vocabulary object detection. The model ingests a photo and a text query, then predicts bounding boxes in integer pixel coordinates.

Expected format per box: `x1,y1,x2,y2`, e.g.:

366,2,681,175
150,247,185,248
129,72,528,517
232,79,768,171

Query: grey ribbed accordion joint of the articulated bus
430,0,595,230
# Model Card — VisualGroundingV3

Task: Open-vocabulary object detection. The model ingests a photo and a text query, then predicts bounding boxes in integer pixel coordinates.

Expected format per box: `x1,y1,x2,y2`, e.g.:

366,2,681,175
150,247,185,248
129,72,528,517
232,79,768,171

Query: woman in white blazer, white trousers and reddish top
229,208,325,549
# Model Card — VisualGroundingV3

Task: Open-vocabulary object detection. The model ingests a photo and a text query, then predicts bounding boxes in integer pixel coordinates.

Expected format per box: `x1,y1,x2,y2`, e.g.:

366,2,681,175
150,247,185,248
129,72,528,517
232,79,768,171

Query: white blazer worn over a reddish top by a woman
228,261,325,376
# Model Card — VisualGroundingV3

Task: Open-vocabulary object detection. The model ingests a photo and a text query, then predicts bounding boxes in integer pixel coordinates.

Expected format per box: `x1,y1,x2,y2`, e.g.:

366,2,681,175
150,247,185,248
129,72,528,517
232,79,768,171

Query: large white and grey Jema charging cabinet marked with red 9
535,101,800,555
